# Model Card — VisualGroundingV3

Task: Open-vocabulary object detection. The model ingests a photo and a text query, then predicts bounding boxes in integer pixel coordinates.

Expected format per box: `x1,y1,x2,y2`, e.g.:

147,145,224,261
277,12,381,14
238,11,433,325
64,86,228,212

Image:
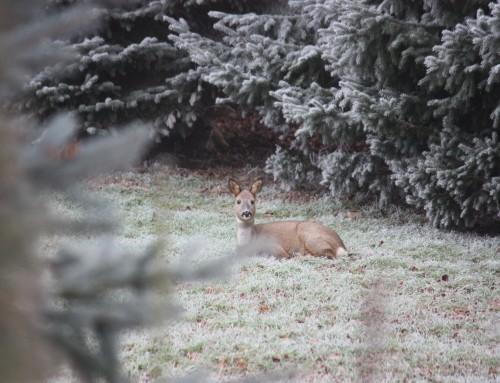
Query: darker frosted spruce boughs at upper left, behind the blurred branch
13,0,280,140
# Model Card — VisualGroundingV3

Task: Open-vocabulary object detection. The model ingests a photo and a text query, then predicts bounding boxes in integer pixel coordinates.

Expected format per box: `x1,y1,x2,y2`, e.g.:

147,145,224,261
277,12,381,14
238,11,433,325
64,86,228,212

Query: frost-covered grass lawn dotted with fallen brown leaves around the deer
47,172,500,382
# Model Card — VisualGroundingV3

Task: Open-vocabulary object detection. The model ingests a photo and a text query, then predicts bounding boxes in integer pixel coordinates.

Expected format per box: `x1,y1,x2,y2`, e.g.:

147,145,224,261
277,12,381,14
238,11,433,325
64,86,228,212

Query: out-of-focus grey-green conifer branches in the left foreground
0,0,292,383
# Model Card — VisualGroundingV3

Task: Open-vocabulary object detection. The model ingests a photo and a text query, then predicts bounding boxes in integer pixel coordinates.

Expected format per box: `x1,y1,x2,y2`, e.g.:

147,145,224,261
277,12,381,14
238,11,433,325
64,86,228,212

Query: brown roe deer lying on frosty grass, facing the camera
229,178,347,258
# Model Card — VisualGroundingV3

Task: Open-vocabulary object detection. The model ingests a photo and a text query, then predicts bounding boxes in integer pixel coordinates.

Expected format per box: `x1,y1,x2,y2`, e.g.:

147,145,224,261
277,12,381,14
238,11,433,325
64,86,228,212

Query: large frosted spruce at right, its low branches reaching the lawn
173,0,500,227
